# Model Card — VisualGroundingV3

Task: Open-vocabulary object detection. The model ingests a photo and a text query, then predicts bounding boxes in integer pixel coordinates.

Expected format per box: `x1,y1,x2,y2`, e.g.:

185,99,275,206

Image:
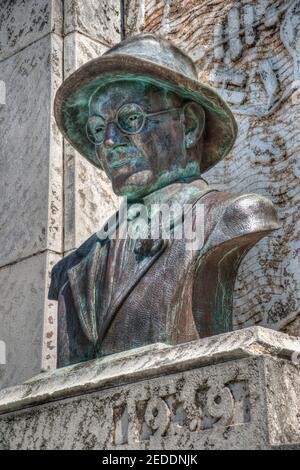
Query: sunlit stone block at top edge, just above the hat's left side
64,0,121,46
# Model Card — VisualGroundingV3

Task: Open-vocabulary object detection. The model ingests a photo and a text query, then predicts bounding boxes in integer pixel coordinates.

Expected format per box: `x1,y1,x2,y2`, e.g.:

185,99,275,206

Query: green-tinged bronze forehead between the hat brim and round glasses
90,80,178,116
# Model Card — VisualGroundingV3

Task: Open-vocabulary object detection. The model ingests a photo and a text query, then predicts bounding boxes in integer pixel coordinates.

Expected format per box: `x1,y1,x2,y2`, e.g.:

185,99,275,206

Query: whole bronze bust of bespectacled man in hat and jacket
49,34,280,367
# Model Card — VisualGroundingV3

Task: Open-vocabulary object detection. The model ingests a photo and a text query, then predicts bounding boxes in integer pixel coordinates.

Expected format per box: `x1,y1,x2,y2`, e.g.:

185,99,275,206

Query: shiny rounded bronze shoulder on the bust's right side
203,193,281,252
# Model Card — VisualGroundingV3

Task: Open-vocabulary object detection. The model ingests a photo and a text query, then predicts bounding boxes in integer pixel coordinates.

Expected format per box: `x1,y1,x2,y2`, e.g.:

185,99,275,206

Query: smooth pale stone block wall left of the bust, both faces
0,0,120,388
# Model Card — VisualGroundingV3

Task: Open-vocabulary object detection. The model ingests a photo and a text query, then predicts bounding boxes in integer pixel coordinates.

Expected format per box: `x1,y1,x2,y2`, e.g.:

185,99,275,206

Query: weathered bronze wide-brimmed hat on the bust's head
54,34,237,173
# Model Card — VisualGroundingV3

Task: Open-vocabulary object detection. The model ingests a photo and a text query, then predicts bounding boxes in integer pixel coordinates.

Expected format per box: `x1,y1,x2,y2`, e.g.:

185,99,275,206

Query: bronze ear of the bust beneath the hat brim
183,101,205,149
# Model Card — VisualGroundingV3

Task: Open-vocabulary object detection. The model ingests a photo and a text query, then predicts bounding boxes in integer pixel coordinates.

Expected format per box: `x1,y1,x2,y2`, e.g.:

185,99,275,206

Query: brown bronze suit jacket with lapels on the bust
49,181,280,367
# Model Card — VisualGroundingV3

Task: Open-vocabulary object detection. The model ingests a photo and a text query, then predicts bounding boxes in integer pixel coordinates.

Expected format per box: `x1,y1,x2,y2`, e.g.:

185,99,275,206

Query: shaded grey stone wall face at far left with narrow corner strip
0,0,63,386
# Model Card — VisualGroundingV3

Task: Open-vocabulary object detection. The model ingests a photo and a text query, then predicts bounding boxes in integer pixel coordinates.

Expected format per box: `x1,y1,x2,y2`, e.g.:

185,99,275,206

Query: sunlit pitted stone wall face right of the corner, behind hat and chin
64,0,121,253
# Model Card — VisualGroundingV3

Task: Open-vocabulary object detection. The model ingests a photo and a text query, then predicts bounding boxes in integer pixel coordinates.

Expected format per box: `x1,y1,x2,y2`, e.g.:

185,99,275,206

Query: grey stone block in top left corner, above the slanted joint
0,0,63,61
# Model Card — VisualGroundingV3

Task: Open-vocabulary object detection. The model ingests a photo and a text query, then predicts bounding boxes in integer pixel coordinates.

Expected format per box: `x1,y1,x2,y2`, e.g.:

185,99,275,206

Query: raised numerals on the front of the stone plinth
112,379,250,446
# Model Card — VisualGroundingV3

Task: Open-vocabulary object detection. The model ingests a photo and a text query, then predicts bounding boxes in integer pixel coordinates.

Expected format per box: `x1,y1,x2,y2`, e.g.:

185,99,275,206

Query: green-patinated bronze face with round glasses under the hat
88,81,203,200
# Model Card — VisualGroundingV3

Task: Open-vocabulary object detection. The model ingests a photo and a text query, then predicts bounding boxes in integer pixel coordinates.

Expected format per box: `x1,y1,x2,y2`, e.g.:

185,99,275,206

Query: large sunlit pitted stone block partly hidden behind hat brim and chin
64,32,118,252
